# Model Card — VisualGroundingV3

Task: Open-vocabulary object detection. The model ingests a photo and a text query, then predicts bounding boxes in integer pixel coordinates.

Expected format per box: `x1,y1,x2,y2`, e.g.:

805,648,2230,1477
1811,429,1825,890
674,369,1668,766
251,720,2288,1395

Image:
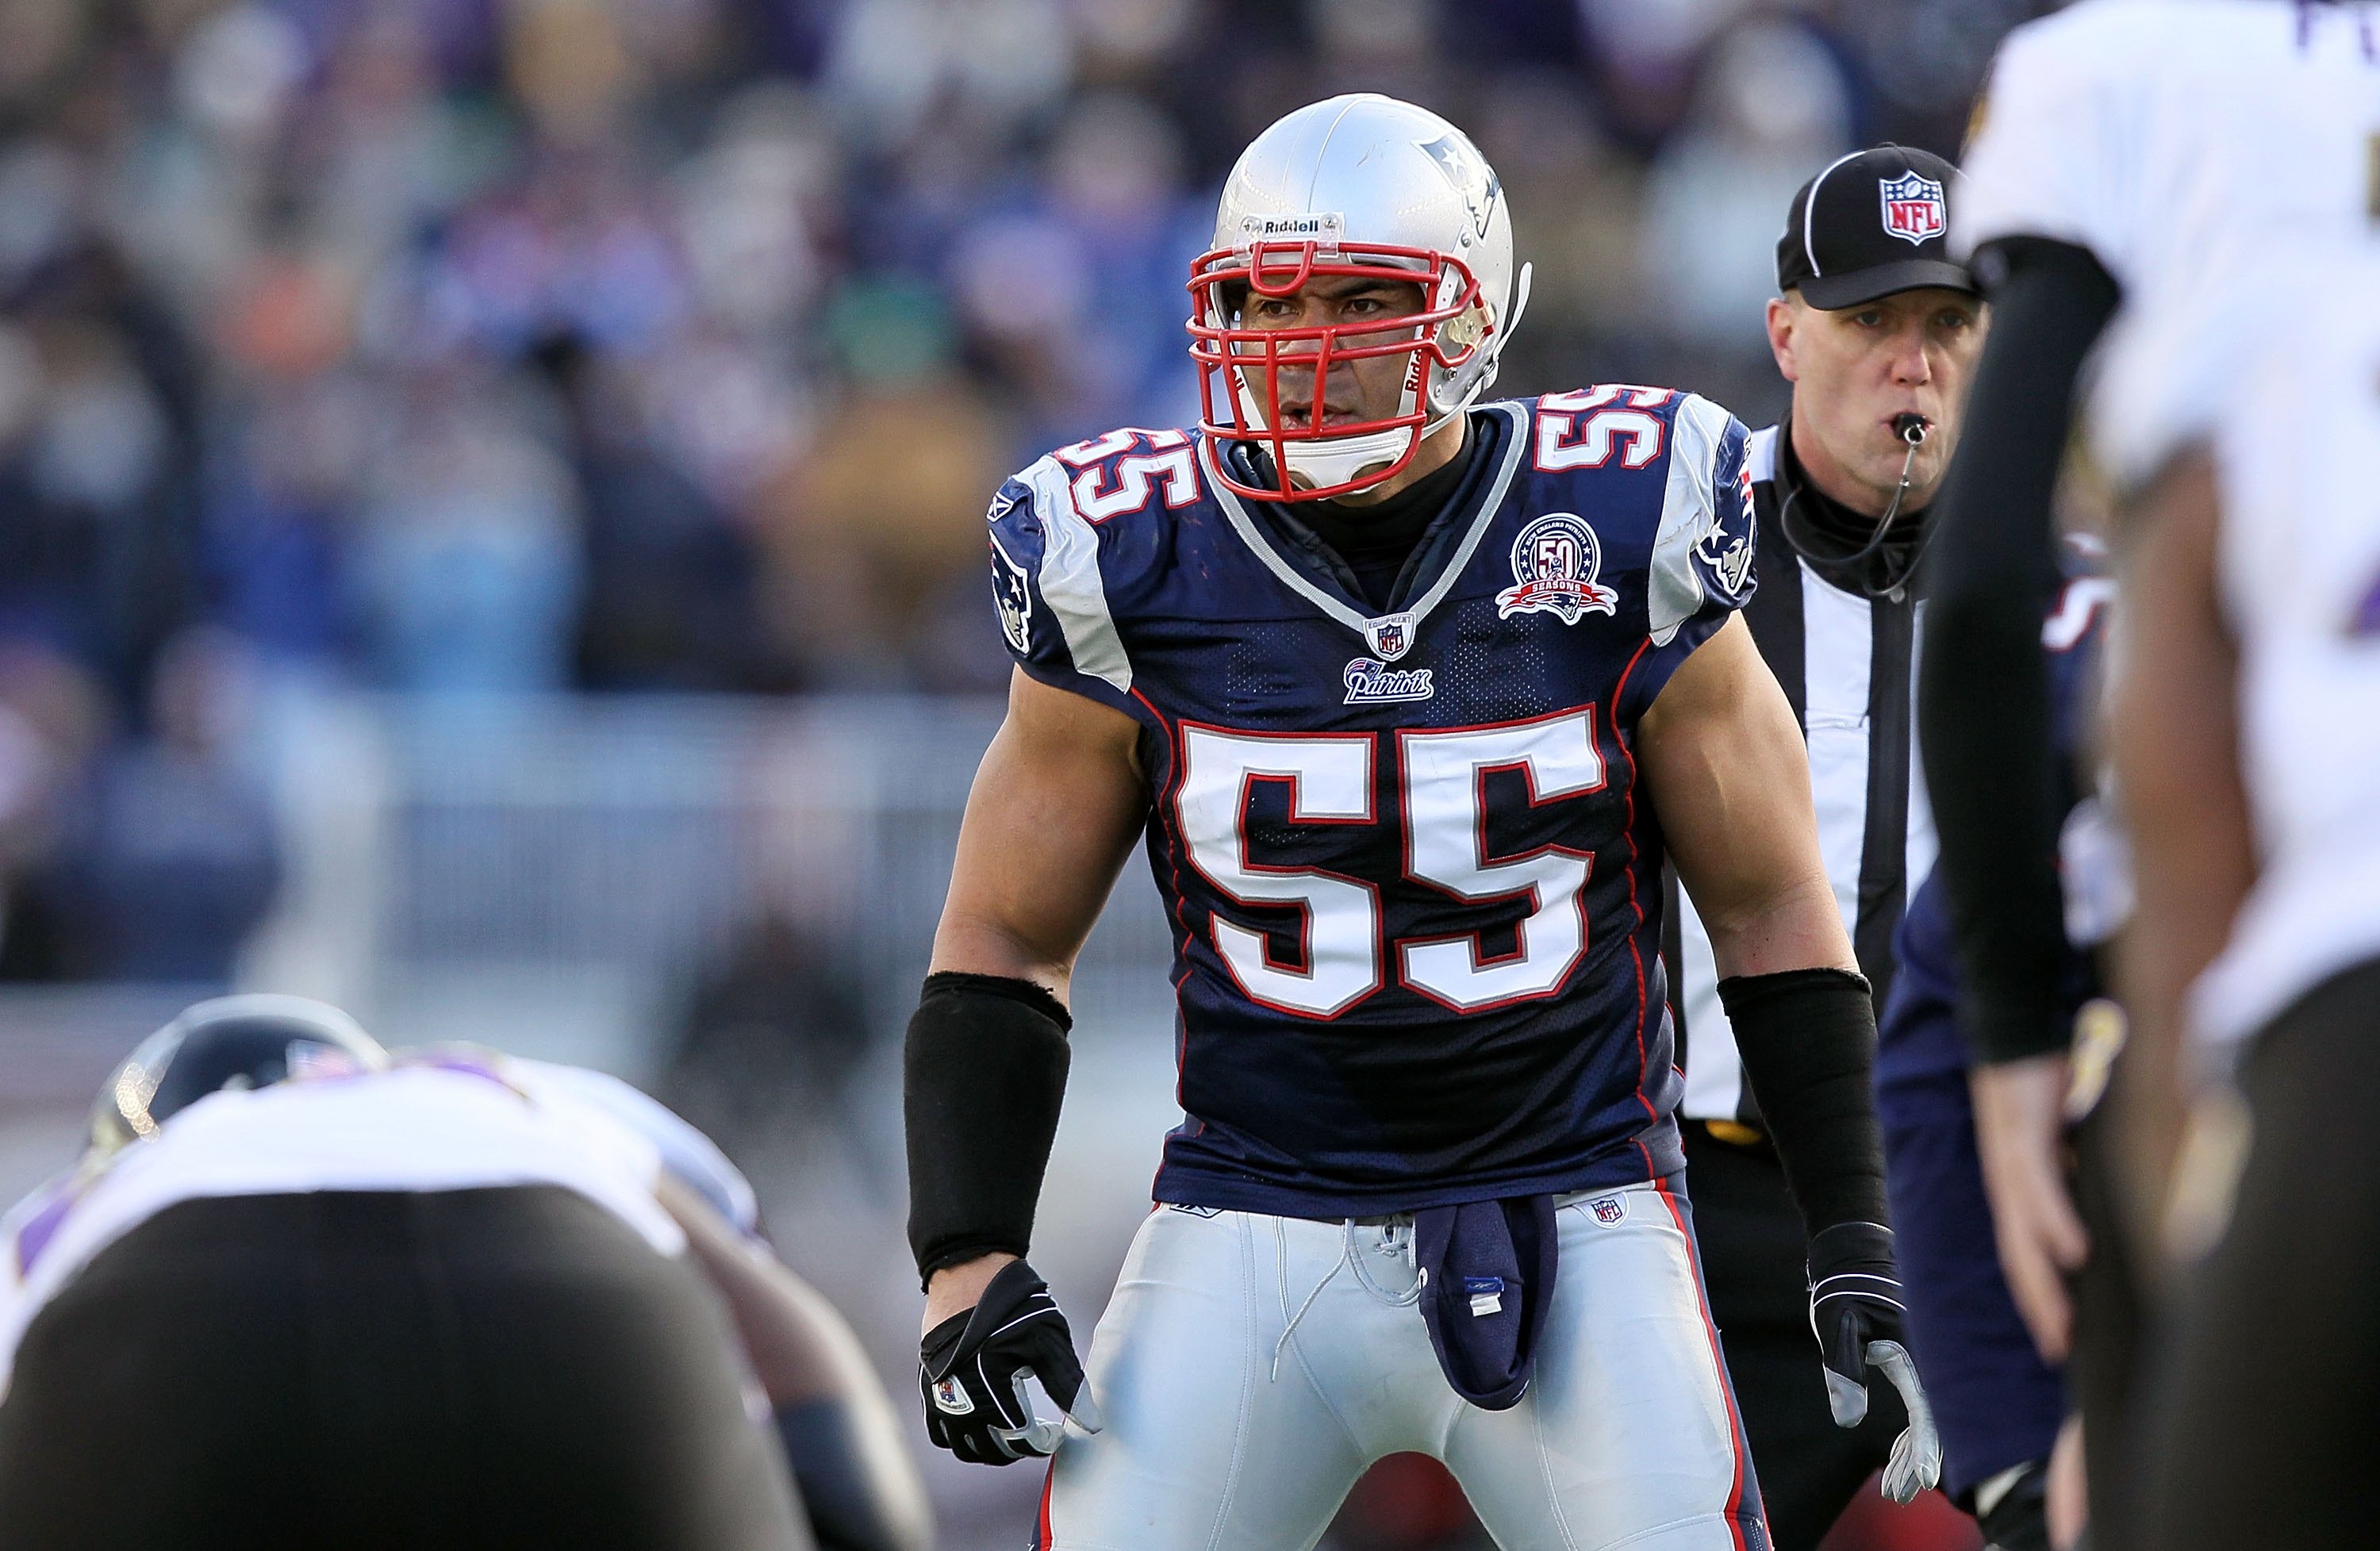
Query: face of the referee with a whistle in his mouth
1768,290,1985,516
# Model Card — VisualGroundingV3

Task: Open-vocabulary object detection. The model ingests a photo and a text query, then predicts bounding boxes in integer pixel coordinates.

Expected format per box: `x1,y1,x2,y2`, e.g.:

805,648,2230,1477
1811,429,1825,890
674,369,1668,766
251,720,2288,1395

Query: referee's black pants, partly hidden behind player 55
1680,1120,1909,1551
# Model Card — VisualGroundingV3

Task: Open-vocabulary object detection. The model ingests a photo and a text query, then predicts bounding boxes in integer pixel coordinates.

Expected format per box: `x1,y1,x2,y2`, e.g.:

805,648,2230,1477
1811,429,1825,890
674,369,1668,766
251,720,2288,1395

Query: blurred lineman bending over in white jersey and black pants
0,996,931,1551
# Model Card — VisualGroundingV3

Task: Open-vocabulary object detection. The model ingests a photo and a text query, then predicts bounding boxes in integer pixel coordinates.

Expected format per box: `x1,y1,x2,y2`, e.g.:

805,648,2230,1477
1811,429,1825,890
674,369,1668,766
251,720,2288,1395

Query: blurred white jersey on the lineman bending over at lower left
0,1054,724,1394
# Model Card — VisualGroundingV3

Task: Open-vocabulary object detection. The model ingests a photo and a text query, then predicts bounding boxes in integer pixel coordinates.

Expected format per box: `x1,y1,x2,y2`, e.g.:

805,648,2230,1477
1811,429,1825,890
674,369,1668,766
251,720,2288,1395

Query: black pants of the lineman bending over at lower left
0,1187,812,1551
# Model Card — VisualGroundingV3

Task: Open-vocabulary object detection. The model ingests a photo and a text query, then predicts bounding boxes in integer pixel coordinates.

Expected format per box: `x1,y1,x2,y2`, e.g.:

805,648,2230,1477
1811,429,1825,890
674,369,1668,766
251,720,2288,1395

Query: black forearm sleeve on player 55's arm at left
902,973,1071,1277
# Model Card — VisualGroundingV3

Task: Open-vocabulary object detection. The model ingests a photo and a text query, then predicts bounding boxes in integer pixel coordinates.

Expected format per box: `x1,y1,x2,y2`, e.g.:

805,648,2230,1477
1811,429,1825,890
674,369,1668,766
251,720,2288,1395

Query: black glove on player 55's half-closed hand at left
919,1261,1100,1465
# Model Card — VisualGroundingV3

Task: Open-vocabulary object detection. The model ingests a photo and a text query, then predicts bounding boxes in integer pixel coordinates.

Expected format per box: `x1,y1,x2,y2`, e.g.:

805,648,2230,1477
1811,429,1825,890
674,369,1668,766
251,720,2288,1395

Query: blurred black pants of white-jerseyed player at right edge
2147,958,2380,1551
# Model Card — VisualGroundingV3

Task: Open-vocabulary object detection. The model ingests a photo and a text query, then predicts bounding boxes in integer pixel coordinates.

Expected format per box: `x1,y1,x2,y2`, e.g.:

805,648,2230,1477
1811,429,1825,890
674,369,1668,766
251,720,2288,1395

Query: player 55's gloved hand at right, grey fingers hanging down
1809,1223,1942,1503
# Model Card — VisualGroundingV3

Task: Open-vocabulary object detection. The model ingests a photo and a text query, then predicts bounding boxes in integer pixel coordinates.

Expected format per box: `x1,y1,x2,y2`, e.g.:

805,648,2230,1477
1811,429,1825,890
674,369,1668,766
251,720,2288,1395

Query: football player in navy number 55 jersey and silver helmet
904,95,1940,1551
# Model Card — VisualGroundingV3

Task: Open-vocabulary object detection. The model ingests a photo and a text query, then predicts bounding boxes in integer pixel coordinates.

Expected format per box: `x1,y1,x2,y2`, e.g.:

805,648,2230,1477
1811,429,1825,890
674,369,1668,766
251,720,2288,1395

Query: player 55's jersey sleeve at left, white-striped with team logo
988,457,1135,714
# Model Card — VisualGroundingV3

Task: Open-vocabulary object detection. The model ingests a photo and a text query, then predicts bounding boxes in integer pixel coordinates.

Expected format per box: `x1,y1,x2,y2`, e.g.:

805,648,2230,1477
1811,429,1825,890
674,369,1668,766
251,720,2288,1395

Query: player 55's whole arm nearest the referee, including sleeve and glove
1635,614,1942,1501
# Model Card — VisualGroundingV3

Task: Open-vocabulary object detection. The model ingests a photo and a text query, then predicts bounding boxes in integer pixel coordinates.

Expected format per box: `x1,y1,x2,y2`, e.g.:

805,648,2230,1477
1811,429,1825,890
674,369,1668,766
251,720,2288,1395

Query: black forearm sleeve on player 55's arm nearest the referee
1718,968,1892,1237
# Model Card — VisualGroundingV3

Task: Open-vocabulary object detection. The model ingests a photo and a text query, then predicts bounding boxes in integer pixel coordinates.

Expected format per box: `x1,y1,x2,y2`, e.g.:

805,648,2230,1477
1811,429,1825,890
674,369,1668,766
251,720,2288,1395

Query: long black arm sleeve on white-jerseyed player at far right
1918,238,2118,1061
